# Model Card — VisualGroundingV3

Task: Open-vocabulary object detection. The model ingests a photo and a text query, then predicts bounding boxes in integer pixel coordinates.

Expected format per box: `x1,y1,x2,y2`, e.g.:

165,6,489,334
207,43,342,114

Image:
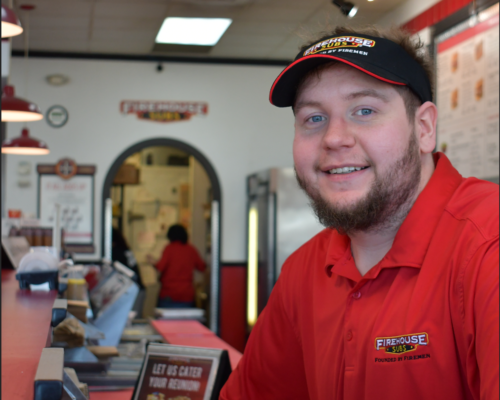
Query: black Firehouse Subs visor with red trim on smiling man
269,33,432,107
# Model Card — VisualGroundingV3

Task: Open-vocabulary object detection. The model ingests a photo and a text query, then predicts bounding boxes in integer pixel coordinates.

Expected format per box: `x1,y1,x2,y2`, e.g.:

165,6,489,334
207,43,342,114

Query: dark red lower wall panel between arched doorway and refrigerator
220,266,247,353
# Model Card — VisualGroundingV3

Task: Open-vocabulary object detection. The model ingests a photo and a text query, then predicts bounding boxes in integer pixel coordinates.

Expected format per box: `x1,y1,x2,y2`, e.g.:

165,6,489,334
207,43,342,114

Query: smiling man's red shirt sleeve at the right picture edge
463,238,499,400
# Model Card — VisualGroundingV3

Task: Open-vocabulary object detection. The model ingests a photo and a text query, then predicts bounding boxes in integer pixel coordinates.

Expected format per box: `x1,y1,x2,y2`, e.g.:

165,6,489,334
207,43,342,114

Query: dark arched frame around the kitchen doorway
101,138,222,334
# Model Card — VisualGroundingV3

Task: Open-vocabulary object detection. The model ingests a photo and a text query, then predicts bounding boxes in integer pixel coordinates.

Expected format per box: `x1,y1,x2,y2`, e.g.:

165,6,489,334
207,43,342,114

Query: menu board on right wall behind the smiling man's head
436,4,499,179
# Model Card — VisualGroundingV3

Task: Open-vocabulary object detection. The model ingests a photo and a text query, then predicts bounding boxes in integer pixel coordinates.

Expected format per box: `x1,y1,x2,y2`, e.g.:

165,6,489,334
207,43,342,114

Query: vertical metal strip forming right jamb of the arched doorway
209,200,220,334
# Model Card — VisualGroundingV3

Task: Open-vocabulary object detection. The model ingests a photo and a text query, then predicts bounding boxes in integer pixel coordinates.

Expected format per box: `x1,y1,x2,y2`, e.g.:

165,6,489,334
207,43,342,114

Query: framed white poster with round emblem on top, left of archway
37,159,95,253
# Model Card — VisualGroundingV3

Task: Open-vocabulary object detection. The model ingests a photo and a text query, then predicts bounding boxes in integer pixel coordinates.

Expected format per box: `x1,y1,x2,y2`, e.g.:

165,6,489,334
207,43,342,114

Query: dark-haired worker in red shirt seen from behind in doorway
147,225,206,308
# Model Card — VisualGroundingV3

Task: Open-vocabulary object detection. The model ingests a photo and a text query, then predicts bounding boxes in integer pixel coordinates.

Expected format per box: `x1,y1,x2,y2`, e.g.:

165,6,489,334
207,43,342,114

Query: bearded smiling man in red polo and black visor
220,28,499,400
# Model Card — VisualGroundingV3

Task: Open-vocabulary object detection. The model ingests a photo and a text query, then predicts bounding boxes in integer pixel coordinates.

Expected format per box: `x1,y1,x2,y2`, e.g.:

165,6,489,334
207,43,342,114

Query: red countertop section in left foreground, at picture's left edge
2,270,57,400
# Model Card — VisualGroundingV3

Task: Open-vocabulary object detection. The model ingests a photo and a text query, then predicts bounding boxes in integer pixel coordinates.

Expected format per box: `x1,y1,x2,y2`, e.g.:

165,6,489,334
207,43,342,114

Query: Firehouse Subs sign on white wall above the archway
120,100,208,122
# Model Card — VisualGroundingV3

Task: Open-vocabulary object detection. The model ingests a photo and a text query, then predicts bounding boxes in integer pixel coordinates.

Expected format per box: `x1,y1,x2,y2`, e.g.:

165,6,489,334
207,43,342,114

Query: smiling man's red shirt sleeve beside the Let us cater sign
219,279,309,400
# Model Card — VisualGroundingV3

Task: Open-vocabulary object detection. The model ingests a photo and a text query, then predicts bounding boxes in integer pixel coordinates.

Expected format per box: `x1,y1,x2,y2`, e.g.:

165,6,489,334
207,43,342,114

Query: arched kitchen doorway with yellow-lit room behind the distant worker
102,138,221,333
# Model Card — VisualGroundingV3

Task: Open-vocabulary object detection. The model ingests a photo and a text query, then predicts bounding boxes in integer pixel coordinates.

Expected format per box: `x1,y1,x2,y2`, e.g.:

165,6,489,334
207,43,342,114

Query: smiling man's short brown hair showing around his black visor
292,26,434,123
